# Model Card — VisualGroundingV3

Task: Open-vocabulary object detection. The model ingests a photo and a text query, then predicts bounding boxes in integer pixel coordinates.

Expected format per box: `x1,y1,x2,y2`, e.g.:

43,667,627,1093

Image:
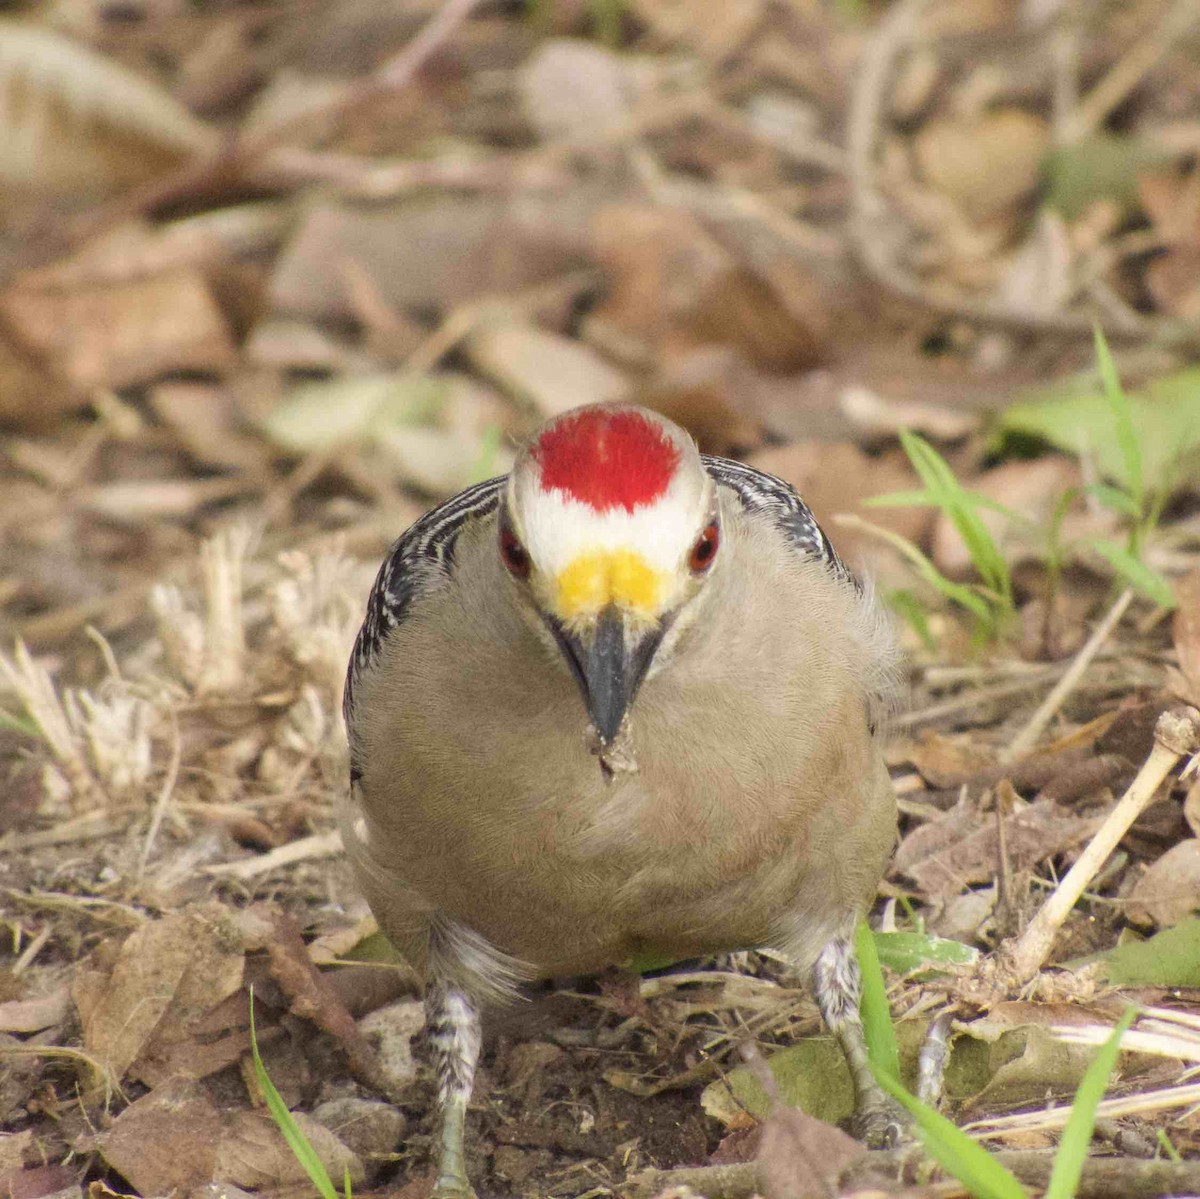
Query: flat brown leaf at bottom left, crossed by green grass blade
96,1080,364,1195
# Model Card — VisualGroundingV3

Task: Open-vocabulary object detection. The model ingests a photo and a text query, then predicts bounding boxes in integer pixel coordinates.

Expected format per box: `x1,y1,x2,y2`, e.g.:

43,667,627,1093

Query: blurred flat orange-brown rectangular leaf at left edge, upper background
0,269,234,389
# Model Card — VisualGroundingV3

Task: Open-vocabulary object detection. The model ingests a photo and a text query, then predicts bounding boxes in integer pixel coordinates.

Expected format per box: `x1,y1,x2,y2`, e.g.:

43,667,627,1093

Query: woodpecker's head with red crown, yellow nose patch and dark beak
499,404,721,744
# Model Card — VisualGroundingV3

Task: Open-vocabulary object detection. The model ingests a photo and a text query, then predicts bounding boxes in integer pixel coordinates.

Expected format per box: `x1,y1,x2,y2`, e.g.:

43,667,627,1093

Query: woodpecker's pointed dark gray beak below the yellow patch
554,605,666,744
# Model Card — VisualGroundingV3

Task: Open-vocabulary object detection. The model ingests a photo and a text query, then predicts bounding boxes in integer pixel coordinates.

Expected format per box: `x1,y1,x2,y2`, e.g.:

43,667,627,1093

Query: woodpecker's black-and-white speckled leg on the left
425,982,480,1199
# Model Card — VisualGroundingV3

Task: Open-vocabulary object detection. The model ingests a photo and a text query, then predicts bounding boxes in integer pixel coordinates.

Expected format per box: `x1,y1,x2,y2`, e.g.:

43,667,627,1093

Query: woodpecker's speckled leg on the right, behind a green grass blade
812,936,901,1149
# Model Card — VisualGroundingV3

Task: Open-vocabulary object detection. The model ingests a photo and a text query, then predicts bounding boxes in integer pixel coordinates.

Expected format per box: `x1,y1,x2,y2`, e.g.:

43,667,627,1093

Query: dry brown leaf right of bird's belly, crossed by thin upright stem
893,799,1102,900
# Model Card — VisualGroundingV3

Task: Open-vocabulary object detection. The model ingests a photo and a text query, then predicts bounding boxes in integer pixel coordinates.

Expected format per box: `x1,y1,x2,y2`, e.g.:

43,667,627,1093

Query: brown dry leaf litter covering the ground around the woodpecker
0,0,1200,1199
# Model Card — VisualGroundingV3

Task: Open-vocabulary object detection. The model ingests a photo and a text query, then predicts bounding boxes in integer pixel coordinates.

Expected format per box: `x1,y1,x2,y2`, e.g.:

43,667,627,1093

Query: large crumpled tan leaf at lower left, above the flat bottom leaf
71,903,244,1080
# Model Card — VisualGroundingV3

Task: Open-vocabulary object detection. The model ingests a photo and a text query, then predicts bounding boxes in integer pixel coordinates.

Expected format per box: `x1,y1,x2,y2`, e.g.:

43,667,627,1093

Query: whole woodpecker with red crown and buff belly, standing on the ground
343,404,896,1199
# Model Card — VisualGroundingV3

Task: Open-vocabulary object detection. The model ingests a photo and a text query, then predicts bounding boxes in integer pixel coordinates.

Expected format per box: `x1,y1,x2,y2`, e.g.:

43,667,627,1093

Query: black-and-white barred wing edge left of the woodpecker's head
342,475,508,725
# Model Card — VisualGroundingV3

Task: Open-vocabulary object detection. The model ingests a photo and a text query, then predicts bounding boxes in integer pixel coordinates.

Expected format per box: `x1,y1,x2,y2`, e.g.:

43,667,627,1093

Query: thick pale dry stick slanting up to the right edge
996,707,1200,983
